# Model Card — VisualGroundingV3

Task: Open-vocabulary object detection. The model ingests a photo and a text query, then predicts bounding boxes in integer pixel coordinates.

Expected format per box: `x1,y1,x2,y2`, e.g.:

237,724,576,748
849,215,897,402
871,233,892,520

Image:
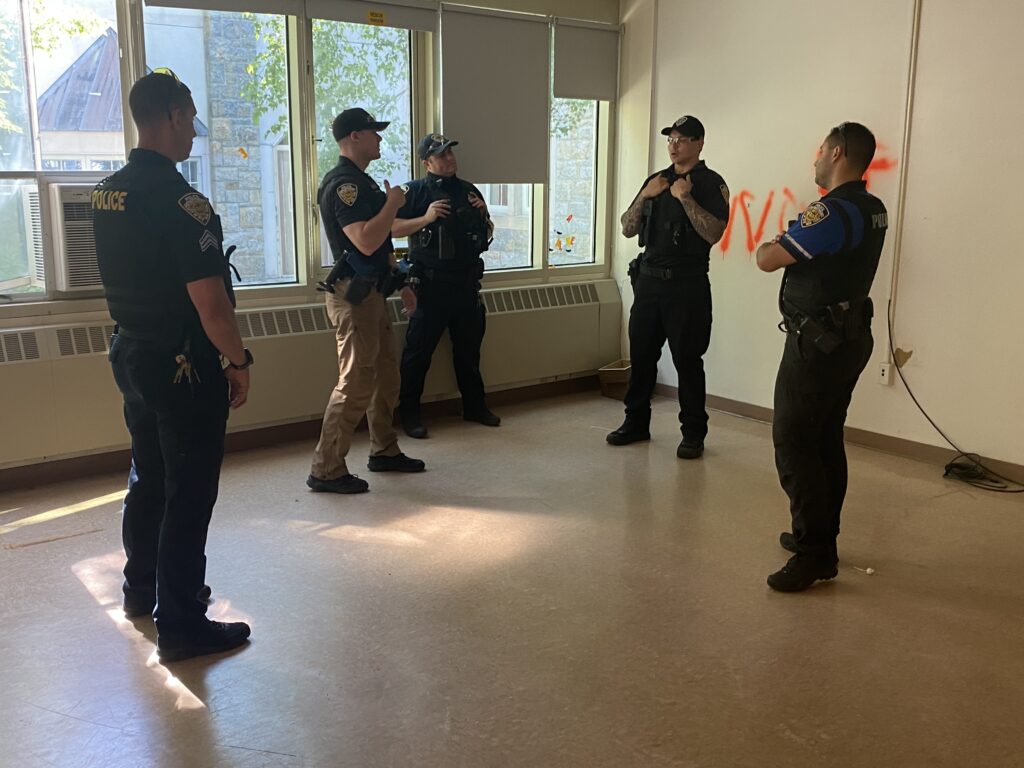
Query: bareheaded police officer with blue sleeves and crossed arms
757,123,889,592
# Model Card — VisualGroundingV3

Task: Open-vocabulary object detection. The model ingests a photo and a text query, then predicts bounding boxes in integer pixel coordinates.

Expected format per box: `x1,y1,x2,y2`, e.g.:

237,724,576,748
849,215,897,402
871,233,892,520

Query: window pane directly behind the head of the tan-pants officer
312,18,413,266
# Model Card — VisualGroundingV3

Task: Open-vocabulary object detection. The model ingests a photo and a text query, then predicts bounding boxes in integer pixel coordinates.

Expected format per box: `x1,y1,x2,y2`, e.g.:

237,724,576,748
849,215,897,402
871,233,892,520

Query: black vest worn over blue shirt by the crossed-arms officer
782,181,889,314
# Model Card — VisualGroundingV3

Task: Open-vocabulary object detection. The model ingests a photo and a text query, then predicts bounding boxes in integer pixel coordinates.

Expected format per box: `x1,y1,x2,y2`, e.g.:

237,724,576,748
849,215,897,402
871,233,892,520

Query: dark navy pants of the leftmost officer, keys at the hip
110,335,228,633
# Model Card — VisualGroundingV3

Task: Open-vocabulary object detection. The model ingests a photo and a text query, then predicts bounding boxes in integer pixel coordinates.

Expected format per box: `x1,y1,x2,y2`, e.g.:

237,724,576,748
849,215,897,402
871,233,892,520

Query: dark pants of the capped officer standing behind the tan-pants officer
398,275,486,418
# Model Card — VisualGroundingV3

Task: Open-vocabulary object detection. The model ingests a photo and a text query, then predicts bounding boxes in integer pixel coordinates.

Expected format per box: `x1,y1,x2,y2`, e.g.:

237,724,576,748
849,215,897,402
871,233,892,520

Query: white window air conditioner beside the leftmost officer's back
50,182,103,293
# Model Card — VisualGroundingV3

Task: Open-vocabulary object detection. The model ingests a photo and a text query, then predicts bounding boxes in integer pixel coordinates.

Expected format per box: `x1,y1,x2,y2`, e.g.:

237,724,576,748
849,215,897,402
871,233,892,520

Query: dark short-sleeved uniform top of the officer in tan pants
316,157,394,276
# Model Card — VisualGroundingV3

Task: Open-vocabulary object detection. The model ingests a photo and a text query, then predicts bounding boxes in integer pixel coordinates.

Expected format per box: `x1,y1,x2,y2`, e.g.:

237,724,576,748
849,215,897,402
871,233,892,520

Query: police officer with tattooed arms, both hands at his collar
607,115,729,459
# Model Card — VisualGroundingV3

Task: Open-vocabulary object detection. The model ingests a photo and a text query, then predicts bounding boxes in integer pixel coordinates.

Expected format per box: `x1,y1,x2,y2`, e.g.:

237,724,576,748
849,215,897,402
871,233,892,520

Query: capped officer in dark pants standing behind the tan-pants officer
392,133,501,437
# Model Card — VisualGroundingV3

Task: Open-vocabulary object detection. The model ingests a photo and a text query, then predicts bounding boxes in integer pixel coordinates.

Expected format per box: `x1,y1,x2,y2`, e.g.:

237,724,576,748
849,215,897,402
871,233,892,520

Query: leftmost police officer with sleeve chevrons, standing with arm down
92,70,253,662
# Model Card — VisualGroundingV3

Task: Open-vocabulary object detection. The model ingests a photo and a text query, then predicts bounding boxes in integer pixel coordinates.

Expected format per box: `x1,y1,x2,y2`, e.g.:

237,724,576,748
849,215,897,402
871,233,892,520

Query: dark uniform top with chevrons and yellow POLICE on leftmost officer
92,148,234,353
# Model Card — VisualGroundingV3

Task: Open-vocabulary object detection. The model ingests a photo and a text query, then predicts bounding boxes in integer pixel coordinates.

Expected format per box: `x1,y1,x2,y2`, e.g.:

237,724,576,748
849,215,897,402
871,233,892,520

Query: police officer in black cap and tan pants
306,109,425,494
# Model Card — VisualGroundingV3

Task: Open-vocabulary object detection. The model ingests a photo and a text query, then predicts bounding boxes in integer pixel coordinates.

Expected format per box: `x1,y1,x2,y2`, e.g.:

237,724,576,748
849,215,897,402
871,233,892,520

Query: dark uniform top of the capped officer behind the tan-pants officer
396,173,494,269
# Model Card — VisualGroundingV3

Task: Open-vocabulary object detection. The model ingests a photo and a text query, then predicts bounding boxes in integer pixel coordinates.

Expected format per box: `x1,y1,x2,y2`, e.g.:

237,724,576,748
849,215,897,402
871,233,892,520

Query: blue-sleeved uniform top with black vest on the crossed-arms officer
778,181,889,311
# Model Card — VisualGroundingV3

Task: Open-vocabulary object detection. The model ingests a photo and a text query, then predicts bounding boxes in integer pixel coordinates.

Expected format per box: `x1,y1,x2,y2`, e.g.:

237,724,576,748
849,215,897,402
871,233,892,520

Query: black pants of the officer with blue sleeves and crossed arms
772,330,873,563
